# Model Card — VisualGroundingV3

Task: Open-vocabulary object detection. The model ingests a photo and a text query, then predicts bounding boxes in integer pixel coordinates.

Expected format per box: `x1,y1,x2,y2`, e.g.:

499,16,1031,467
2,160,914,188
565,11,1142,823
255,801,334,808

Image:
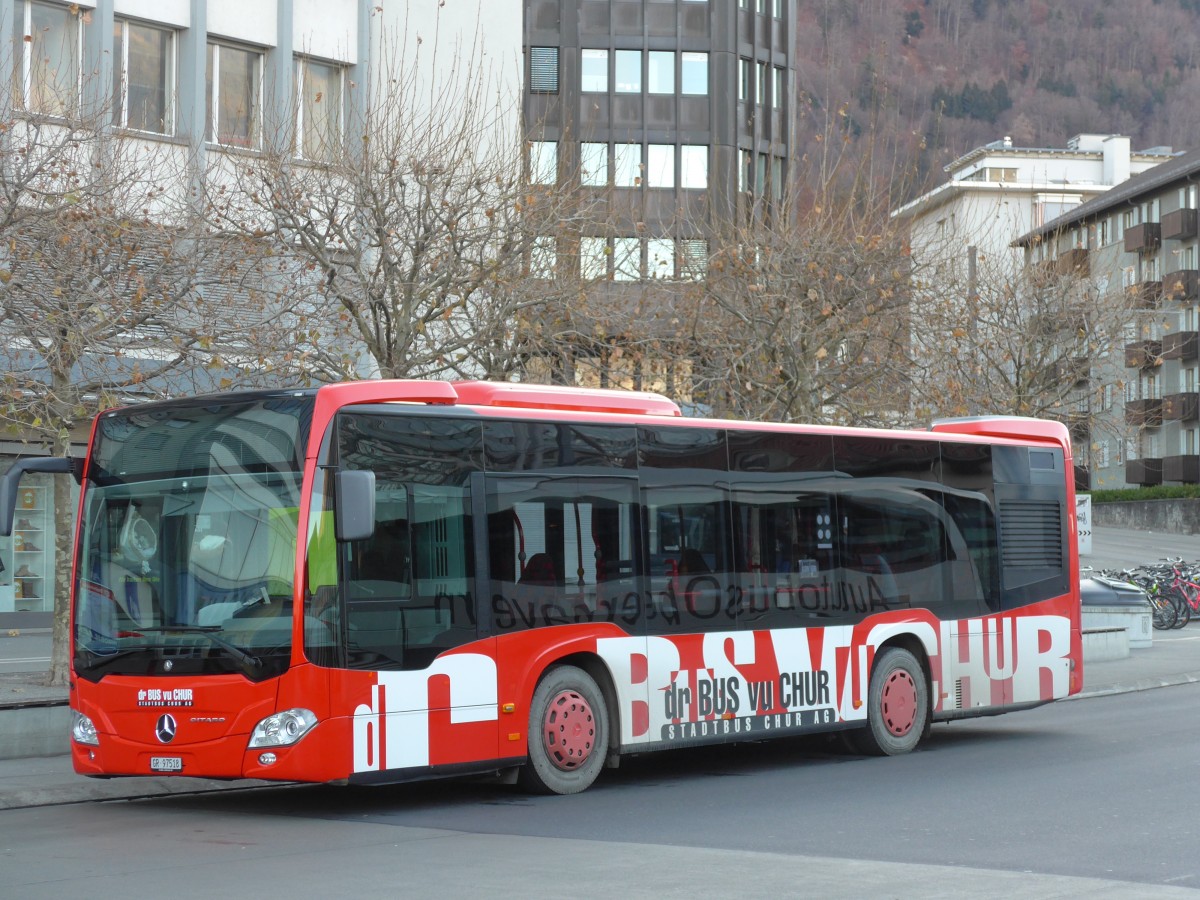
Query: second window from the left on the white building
113,19,175,134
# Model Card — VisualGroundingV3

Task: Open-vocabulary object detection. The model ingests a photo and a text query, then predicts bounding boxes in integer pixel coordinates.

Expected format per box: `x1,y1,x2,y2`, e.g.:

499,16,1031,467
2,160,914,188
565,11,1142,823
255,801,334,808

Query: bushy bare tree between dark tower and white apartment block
688,193,908,424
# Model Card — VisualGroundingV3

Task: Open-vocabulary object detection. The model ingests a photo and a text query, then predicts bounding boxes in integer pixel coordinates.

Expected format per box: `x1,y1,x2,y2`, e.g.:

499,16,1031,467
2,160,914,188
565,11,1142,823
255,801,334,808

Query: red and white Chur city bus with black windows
0,380,1082,793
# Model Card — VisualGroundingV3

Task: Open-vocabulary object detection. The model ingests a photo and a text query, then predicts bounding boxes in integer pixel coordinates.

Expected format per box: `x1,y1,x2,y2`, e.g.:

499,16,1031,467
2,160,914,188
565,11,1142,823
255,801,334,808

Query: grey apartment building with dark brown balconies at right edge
1016,150,1200,487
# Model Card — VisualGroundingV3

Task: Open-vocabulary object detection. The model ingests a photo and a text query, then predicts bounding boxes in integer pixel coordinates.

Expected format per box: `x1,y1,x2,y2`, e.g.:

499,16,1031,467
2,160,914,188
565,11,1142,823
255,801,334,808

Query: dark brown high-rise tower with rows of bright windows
523,0,794,393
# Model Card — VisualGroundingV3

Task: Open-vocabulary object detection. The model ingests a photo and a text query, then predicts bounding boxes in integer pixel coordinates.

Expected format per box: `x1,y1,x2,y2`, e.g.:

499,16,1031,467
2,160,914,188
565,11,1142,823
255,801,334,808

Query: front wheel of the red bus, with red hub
520,666,608,794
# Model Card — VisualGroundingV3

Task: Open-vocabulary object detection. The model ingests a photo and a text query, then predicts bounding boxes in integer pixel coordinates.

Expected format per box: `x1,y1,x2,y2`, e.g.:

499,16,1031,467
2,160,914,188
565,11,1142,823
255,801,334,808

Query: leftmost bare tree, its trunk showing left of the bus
0,113,295,684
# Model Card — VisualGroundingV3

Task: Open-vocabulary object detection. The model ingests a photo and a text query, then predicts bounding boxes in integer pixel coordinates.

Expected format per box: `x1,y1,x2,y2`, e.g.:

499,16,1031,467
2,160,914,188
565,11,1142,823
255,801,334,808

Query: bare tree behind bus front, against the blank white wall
209,17,590,379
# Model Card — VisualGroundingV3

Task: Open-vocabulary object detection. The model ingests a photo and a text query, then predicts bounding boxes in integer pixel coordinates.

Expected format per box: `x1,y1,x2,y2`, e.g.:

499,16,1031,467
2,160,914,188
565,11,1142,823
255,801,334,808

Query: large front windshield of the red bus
74,396,311,680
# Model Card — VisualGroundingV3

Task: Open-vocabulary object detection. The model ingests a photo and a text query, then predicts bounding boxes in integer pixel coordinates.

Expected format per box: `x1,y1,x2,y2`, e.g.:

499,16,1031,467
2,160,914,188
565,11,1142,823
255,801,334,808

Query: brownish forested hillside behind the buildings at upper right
797,0,1200,202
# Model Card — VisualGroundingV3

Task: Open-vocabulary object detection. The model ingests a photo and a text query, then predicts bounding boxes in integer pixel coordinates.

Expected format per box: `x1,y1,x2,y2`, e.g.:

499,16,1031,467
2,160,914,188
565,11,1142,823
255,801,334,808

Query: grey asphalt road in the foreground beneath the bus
0,684,1200,900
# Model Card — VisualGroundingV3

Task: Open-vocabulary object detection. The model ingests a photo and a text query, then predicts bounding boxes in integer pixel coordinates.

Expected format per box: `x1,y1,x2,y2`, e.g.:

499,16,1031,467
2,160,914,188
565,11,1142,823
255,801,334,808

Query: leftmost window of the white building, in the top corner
12,1,83,115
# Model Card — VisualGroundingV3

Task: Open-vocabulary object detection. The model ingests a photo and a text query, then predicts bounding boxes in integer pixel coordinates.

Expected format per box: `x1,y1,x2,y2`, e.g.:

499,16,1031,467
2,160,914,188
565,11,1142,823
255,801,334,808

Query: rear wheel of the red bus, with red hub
854,647,930,756
